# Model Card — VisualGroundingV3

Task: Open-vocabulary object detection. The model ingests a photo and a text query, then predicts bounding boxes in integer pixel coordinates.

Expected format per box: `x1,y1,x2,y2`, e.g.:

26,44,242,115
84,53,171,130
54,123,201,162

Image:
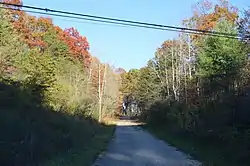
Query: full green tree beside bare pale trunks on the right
198,21,247,93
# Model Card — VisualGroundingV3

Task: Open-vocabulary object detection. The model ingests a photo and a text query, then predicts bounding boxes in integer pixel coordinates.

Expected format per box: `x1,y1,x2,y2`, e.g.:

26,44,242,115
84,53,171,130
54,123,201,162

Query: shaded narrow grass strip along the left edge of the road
42,122,115,166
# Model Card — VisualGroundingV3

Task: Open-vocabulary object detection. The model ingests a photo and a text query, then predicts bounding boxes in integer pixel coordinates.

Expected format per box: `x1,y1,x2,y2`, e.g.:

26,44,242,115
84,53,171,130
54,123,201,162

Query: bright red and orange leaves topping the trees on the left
3,0,91,67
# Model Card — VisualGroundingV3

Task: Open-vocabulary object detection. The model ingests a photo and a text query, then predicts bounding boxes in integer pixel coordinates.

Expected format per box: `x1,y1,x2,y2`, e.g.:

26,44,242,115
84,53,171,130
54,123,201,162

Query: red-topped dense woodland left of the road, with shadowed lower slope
0,0,120,166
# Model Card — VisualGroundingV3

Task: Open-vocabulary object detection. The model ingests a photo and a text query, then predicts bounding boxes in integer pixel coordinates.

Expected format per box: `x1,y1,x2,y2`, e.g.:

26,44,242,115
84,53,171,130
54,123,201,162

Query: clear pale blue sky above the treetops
23,0,250,70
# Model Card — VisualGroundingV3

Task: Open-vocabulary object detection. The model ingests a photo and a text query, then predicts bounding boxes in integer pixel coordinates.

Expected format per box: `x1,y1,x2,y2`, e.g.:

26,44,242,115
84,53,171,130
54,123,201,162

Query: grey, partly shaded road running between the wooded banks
93,118,201,166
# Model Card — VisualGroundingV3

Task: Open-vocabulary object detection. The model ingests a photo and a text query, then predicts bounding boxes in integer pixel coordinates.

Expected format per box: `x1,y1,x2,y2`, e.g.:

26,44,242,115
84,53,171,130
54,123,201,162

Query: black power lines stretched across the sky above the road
0,2,240,38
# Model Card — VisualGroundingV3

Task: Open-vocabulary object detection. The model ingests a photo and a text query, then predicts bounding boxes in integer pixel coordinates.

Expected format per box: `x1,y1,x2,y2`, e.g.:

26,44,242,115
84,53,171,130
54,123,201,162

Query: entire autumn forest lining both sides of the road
0,0,250,166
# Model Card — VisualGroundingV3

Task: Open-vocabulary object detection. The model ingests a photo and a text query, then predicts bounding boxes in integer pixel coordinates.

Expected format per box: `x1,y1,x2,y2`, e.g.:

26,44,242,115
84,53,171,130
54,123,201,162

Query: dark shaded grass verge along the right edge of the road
144,124,243,166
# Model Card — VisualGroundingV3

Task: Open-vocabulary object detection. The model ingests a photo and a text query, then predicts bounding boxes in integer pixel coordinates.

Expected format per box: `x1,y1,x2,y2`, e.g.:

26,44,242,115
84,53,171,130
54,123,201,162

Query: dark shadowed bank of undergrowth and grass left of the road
0,82,115,166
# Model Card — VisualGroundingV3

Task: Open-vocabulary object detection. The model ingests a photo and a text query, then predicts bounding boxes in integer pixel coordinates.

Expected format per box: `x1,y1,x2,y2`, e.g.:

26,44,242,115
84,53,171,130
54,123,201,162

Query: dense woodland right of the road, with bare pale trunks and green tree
121,0,250,166
